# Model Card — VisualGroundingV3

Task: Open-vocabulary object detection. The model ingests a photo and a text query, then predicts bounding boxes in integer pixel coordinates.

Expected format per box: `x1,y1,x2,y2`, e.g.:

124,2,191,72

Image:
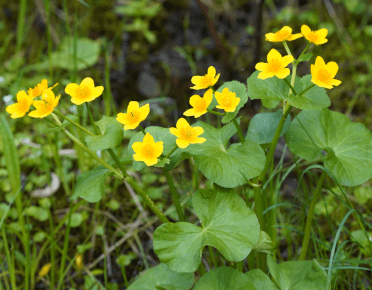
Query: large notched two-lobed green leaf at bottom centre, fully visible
154,188,260,272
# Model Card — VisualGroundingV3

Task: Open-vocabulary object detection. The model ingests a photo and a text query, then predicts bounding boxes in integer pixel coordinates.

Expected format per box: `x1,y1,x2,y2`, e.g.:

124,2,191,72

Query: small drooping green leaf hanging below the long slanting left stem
71,166,112,202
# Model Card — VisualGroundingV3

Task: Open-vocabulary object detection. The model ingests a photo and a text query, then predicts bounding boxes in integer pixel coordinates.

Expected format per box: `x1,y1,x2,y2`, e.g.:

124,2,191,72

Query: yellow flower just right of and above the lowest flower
169,118,207,148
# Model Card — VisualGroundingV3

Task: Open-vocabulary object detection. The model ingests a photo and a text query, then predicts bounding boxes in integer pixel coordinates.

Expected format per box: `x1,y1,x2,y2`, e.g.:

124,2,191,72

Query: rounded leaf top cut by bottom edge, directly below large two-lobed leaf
194,267,256,290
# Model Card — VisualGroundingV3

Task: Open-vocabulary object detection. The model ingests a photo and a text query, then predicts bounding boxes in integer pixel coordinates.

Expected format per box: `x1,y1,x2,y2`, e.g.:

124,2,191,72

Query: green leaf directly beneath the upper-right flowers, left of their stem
247,71,302,109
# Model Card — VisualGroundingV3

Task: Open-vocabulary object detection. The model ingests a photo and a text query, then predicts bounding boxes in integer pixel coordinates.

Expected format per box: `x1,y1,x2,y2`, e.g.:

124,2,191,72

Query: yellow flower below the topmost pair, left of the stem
256,48,293,80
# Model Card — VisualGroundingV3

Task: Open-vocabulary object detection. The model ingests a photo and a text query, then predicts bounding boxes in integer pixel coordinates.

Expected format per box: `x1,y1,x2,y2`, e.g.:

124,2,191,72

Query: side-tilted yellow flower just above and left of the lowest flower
116,101,150,131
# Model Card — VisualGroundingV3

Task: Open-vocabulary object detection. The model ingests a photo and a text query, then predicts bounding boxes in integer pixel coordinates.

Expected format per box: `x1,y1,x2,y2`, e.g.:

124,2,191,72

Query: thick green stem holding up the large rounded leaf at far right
300,171,327,260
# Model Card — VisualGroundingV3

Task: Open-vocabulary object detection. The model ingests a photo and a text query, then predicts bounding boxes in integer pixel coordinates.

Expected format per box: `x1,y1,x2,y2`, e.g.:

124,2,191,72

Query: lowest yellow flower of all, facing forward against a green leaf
132,133,163,166
